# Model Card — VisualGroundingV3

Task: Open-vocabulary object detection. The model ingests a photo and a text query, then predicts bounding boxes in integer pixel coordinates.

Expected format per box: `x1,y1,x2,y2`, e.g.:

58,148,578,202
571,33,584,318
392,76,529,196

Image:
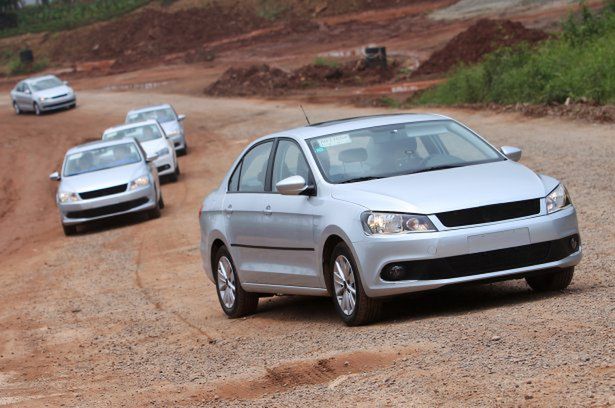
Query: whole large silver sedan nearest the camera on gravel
199,114,581,325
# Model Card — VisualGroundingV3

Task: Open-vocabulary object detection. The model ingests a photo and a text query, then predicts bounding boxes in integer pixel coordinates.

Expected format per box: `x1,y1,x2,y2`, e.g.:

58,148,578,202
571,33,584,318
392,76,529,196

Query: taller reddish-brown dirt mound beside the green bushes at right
413,18,548,76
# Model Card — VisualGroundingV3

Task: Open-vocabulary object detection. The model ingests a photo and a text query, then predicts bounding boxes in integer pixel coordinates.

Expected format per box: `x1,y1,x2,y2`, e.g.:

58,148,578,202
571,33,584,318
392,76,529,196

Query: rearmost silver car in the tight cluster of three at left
126,104,188,156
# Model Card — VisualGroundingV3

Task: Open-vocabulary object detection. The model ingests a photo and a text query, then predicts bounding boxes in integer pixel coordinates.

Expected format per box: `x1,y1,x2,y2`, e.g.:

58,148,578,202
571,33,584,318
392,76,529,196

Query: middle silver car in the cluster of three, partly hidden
102,120,180,181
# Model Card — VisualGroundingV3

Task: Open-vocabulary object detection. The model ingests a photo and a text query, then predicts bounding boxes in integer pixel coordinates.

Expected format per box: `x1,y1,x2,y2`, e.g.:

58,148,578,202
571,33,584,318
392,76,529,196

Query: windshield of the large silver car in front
308,120,505,183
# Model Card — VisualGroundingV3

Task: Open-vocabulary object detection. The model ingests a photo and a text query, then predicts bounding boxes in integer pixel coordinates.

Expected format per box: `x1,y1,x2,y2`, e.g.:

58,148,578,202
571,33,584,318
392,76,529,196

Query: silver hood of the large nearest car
332,160,548,214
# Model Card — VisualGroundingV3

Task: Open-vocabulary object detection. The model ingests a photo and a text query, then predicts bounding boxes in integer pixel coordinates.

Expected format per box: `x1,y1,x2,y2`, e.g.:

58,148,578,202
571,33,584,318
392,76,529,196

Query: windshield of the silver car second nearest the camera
64,143,141,177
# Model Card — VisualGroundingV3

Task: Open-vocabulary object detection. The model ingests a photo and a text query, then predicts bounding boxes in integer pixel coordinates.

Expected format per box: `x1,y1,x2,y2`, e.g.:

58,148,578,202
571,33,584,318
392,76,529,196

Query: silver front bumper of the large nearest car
353,206,582,297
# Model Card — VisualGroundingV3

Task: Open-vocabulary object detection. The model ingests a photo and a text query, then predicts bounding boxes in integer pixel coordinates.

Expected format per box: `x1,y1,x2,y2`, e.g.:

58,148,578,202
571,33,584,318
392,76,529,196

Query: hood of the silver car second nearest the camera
60,162,146,193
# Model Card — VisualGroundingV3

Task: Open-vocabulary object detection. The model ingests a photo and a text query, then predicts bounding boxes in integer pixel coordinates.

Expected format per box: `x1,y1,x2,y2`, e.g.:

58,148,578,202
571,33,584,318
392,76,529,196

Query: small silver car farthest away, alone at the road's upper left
11,75,77,115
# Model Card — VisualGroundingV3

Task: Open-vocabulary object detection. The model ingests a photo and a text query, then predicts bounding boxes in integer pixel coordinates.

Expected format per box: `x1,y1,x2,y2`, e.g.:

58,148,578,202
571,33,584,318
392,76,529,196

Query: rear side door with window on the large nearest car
223,139,273,283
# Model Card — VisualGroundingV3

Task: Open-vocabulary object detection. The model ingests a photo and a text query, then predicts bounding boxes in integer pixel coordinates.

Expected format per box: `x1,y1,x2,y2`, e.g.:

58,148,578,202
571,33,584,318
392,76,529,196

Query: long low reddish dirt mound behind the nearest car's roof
205,60,400,96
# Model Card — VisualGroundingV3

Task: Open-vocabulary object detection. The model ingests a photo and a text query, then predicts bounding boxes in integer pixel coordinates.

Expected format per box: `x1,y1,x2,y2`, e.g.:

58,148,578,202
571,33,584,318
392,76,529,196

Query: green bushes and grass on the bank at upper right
412,0,615,104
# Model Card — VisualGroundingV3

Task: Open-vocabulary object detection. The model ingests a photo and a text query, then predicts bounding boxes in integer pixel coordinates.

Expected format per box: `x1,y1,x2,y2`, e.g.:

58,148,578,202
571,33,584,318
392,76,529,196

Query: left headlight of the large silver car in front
361,211,437,234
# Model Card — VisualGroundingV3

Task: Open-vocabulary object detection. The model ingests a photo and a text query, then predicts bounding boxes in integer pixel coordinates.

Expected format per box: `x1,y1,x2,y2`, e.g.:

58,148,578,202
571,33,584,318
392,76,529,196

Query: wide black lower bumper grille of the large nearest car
380,235,580,281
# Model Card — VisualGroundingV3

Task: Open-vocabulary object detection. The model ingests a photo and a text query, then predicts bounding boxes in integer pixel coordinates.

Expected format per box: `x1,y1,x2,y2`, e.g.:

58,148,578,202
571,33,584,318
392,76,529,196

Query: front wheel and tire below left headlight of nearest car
328,242,382,326
